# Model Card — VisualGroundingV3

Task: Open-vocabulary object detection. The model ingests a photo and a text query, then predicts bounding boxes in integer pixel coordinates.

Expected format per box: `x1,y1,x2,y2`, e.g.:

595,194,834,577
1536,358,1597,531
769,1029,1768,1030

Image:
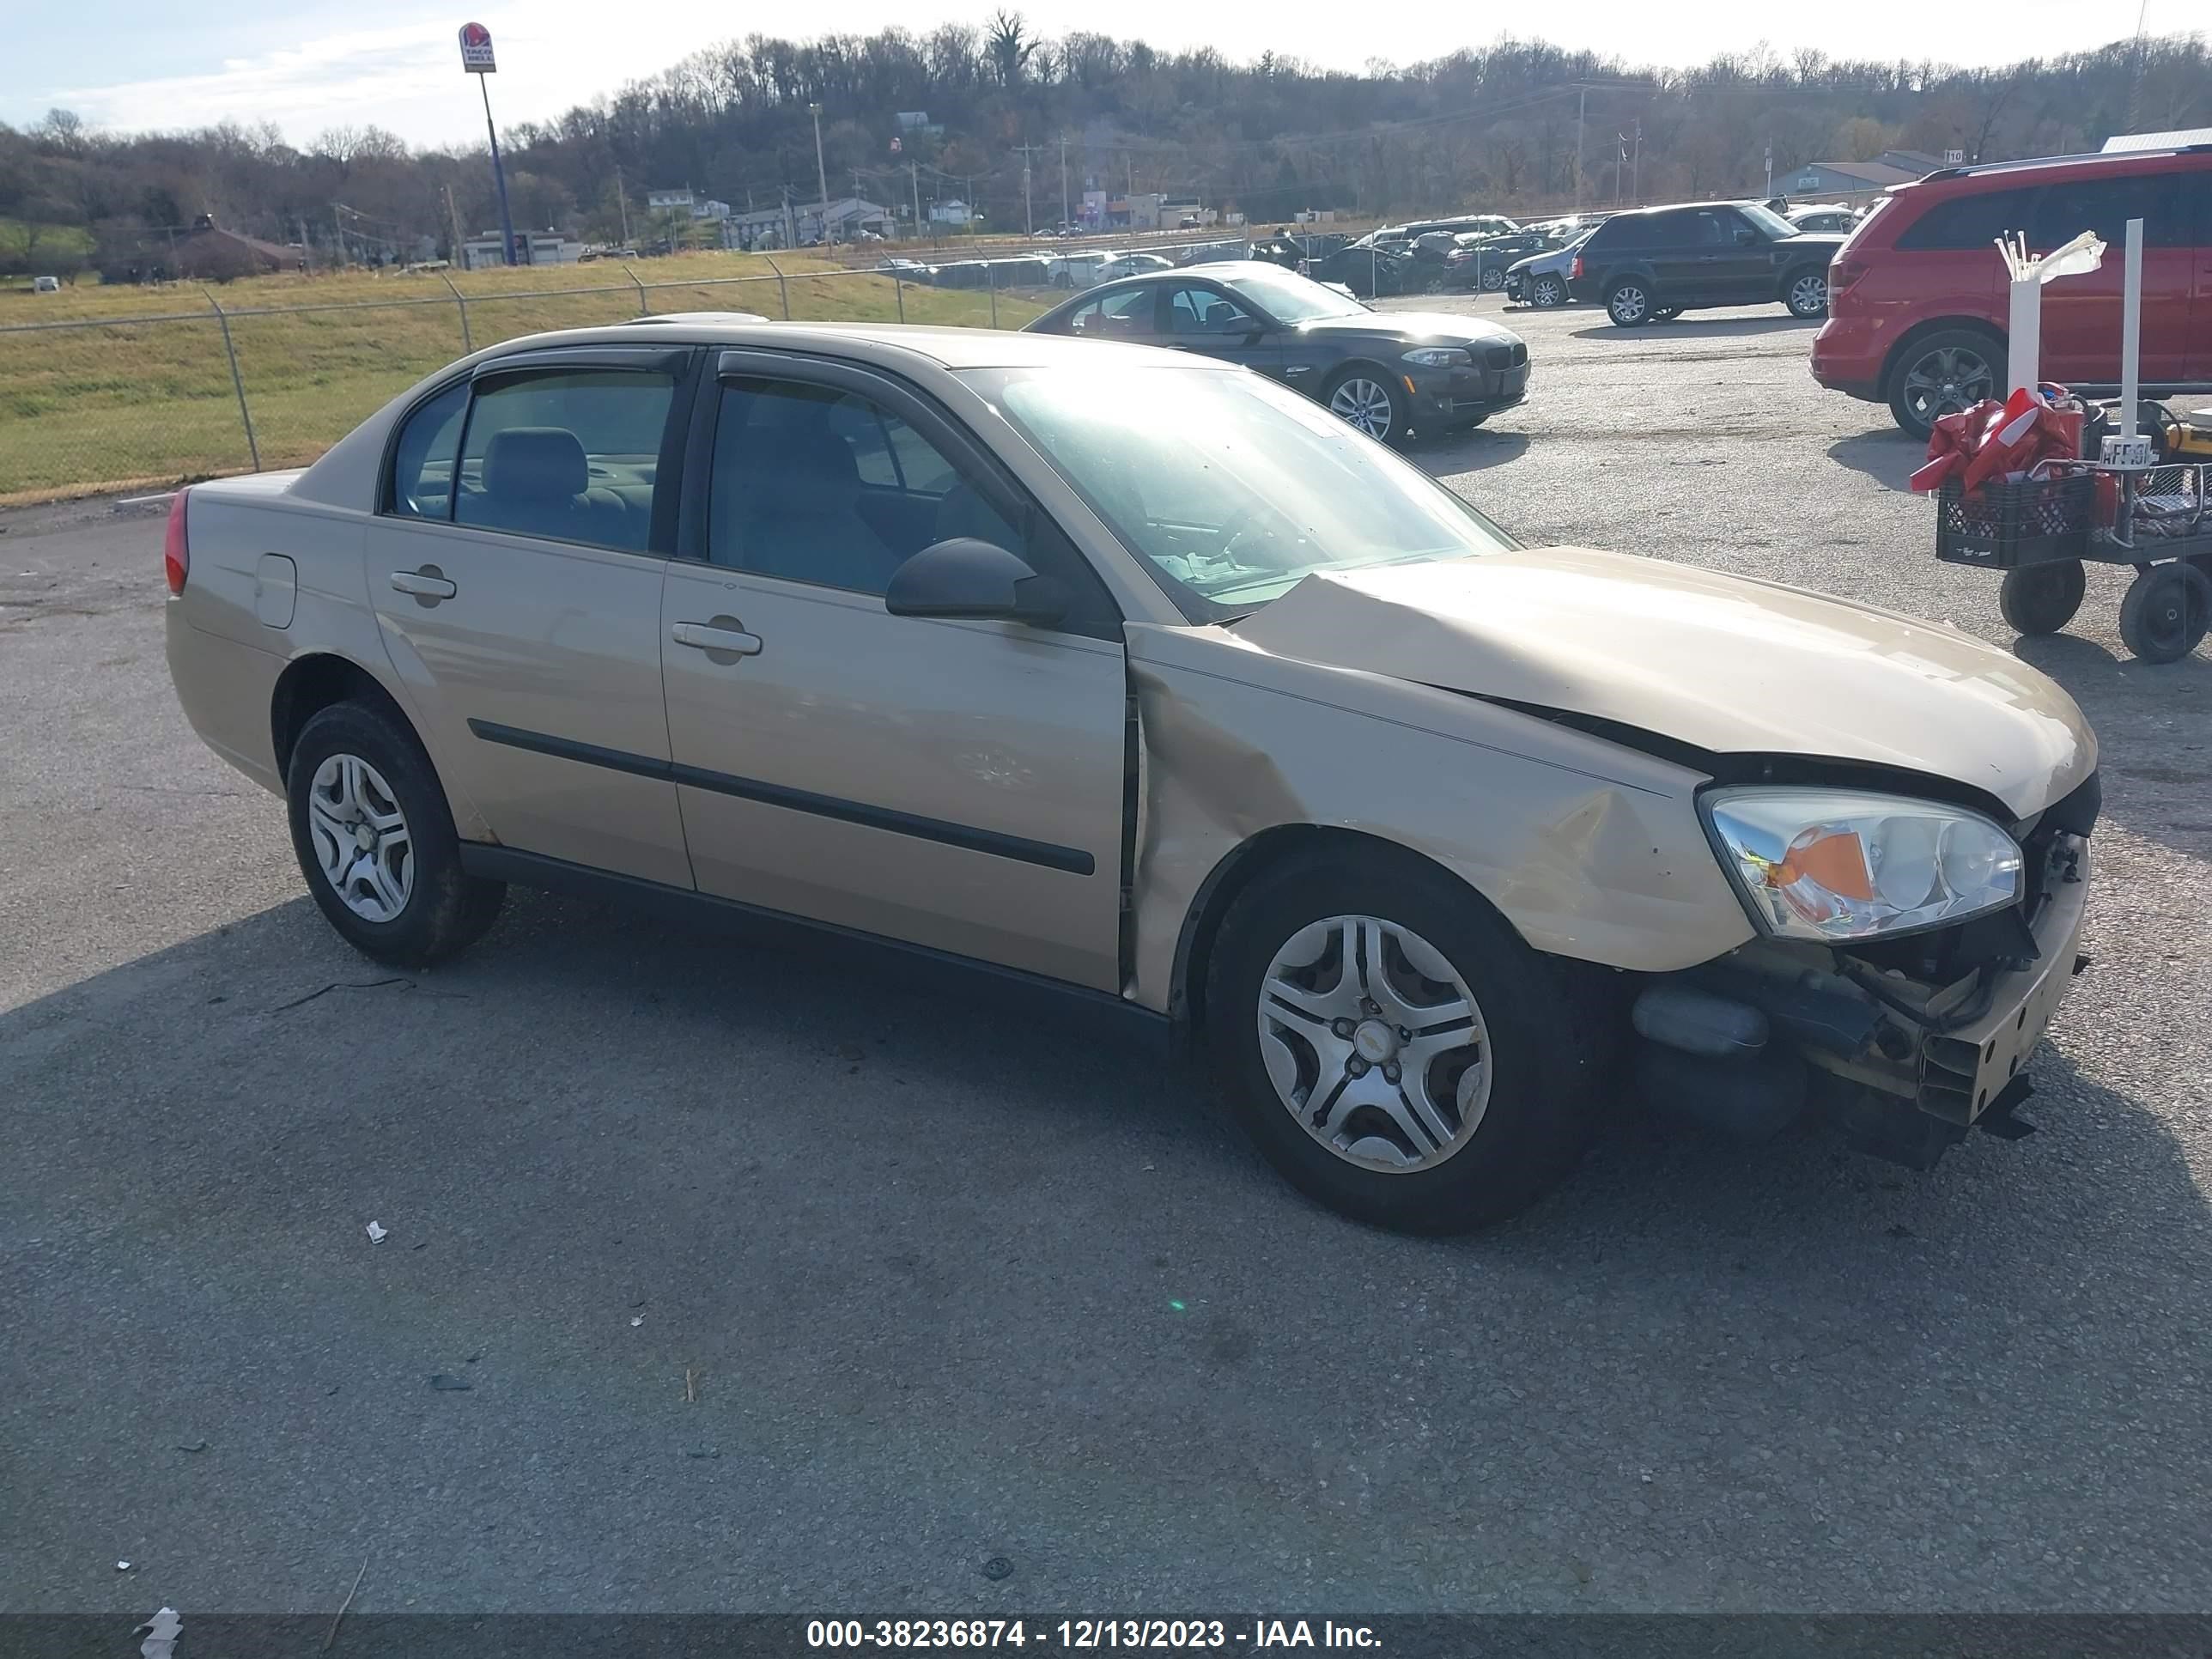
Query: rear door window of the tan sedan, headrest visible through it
453,369,675,553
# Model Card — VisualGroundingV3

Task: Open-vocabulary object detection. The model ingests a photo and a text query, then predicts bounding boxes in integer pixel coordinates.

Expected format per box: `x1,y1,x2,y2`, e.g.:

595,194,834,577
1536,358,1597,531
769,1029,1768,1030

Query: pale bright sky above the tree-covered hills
0,0,2176,143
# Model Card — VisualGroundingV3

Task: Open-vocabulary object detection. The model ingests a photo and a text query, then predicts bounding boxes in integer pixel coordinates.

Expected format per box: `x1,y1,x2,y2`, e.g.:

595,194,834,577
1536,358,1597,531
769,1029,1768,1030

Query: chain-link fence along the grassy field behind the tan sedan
0,228,1486,507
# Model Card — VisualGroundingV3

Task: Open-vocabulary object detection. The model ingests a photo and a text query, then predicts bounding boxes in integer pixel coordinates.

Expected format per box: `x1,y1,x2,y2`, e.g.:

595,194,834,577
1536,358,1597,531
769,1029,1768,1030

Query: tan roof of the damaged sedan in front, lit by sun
483,318,1212,369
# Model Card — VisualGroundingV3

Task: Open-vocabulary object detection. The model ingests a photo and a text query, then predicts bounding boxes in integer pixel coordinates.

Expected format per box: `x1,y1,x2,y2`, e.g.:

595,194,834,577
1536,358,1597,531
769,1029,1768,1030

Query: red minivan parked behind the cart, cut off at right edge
1812,143,2212,438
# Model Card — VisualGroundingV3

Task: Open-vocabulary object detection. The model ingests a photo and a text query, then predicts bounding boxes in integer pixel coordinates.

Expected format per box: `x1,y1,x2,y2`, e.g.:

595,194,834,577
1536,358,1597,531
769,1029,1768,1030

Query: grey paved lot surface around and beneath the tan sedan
0,299,2212,1617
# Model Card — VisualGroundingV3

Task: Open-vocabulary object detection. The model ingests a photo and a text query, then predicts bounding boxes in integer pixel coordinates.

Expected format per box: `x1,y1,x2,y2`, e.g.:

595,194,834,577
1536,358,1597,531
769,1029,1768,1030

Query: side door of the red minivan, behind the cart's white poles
2028,161,2212,383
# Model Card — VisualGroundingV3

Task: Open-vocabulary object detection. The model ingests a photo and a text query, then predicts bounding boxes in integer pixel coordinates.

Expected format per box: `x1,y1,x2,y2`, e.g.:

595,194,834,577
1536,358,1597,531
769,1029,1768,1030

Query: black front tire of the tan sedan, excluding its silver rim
1206,854,1620,1234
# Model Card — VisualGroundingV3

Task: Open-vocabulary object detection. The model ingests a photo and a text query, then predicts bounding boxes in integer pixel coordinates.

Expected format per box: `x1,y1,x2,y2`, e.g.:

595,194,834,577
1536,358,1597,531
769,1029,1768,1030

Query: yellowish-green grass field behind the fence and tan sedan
0,252,1042,504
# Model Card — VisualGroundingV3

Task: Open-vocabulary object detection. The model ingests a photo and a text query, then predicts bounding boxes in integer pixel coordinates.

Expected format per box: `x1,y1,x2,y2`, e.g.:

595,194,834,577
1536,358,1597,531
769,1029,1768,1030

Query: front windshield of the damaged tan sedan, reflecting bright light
967,368,1516,622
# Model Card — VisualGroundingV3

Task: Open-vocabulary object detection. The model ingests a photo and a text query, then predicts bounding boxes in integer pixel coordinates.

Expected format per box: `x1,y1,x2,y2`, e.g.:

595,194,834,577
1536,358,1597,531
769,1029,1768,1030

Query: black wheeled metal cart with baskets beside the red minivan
1936,460,2212,664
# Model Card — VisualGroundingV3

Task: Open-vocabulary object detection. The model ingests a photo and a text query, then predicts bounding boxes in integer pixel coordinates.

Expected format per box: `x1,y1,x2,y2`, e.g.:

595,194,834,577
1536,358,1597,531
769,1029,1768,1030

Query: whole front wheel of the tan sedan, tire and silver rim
1206,856,1604,1232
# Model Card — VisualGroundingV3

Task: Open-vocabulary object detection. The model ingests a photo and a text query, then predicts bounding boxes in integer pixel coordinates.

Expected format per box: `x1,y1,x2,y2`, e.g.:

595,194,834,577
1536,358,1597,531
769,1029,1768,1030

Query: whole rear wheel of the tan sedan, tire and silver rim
285,703,507,967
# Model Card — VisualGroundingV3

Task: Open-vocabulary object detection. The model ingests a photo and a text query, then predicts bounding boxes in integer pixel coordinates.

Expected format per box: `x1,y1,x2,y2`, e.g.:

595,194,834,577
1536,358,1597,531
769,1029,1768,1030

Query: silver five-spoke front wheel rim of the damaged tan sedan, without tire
1259,915,1491,1175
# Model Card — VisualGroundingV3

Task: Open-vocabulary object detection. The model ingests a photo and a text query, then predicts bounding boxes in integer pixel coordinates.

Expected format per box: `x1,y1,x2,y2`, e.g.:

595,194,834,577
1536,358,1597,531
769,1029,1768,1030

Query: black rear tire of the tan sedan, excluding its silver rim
285,703,507,967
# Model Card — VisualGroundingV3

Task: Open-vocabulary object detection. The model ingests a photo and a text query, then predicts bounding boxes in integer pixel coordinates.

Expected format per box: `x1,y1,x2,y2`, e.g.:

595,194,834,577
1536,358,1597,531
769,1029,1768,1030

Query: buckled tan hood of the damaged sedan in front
1237,546,2097,817
